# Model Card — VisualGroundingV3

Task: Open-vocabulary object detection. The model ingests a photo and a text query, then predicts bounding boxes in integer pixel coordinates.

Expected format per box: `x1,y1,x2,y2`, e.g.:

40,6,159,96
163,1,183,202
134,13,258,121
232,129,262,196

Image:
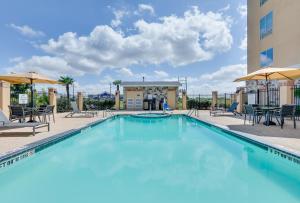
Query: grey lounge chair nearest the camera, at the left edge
0,110,50,136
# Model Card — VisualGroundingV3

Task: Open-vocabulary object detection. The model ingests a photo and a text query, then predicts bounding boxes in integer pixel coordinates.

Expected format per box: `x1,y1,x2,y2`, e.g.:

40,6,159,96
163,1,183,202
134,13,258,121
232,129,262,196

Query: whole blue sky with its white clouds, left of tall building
0,0,247,94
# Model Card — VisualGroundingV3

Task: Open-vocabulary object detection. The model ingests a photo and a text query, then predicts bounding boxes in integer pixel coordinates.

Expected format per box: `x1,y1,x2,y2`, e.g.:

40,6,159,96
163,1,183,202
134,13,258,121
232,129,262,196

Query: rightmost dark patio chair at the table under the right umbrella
274,104,296,128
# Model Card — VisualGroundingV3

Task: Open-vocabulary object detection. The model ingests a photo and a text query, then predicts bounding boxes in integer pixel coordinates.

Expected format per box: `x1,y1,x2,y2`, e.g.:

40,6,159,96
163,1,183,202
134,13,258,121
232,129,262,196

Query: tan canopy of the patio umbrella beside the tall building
234,67,300,82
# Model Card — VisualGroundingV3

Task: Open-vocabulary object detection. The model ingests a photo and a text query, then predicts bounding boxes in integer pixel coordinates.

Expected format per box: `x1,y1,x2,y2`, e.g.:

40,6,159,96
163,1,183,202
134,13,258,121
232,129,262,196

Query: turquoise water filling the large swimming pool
0,116,300,203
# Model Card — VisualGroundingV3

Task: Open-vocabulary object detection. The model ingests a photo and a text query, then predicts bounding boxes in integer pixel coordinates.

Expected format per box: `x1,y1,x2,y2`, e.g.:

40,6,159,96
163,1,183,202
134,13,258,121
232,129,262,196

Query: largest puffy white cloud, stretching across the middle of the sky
7,7,233,79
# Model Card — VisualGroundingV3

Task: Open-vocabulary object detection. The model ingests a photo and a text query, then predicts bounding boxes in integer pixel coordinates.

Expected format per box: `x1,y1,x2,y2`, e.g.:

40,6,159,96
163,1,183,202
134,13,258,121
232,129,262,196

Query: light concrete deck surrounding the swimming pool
0,111,300,156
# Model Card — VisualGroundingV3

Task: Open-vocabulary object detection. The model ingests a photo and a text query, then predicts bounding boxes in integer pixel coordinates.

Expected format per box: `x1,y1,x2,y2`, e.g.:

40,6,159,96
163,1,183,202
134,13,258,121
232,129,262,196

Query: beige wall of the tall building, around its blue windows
247,0,300,73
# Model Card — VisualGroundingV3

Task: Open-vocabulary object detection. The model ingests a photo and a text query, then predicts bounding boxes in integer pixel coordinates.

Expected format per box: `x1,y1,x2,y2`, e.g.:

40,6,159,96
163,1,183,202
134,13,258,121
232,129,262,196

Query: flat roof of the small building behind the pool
121,81,181,87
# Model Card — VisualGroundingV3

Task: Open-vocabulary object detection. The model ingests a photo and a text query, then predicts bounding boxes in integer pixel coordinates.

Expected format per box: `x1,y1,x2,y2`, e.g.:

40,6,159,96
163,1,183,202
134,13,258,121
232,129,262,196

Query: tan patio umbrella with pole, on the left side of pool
0,72,60,107
